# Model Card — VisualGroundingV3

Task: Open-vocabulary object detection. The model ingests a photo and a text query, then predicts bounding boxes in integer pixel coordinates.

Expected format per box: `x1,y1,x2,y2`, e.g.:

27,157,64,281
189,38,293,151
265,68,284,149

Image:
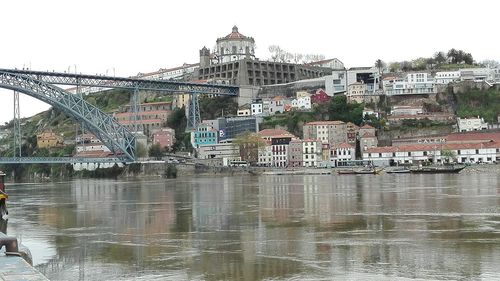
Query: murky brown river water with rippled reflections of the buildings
2,172,500,280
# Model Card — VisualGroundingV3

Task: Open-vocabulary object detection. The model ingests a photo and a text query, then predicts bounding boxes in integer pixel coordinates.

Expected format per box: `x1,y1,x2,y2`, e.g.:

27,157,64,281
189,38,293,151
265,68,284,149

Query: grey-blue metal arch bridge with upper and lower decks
0,69,239,164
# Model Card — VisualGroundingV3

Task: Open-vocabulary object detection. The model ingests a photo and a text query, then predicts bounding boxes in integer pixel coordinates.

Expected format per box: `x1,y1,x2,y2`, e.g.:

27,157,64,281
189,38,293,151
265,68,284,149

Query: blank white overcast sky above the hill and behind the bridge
0,0,500,124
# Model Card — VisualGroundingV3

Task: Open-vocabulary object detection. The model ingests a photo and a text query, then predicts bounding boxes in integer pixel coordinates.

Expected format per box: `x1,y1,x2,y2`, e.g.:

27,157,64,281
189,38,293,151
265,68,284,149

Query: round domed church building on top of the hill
215,25,255,63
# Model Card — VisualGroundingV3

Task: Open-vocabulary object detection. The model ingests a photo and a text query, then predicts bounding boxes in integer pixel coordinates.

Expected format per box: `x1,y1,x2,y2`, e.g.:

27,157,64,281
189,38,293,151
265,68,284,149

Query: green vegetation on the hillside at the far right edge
455,85,500,120
